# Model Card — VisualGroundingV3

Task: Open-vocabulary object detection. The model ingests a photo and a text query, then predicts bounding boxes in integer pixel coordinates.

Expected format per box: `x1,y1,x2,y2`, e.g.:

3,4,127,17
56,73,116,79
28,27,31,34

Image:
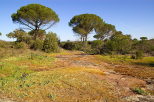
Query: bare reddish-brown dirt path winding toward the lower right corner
53,53,154,102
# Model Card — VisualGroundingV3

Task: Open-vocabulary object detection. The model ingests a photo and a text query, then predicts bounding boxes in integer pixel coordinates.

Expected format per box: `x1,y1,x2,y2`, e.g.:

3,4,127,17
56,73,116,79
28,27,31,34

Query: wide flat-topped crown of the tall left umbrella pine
11,4,59,30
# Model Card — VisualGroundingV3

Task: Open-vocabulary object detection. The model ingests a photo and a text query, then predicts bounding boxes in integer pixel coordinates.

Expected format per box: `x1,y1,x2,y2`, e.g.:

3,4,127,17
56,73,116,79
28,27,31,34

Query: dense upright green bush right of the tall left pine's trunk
43,32,59,53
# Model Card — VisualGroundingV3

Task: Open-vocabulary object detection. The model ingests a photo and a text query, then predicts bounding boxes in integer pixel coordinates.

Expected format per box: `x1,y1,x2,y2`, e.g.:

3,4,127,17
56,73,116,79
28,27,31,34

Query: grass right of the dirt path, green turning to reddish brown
96,55,154,78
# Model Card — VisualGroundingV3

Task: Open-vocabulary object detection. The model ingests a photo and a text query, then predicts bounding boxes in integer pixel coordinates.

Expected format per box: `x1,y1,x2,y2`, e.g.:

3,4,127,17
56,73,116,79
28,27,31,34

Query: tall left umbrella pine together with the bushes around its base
7,4,59,52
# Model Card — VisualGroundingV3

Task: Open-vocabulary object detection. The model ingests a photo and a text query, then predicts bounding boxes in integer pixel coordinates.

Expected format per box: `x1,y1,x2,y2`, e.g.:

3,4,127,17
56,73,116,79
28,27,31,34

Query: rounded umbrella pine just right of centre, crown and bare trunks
69,14,104,42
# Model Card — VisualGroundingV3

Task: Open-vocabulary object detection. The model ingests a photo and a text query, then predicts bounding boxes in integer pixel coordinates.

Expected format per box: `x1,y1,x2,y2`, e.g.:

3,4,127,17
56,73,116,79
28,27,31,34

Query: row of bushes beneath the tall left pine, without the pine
7,30,59,53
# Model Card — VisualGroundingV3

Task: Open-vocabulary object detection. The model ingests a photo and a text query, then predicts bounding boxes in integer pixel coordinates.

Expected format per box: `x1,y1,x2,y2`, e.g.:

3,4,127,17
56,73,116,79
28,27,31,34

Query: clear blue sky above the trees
0,0,154,41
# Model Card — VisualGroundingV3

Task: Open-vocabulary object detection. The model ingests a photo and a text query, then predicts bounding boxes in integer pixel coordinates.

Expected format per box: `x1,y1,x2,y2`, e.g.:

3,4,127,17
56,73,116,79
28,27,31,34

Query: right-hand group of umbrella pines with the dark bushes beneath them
65,14,154,59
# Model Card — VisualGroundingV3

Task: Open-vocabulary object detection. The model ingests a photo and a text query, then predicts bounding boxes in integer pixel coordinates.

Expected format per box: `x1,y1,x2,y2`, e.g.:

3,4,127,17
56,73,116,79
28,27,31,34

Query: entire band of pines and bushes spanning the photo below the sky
0,4,154,58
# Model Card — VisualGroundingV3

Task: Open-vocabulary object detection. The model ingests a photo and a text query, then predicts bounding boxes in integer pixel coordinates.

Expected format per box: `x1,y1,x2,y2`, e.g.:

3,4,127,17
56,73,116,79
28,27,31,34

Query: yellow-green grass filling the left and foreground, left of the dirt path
0,52,119,102
